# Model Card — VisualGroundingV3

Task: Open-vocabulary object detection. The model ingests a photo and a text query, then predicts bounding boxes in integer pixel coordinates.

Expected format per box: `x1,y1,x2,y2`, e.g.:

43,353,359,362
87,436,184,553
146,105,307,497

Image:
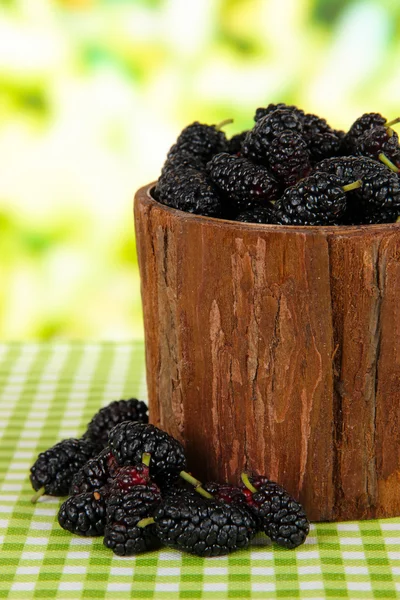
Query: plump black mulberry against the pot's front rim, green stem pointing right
275,172,346,225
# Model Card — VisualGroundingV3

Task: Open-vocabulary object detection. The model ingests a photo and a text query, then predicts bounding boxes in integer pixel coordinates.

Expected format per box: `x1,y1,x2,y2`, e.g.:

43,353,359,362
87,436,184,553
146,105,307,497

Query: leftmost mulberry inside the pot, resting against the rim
155,167,221,217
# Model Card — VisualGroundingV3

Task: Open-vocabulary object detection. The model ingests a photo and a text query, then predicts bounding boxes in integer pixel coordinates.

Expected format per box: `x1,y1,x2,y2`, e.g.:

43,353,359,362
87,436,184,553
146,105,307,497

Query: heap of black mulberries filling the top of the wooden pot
153,103,400,225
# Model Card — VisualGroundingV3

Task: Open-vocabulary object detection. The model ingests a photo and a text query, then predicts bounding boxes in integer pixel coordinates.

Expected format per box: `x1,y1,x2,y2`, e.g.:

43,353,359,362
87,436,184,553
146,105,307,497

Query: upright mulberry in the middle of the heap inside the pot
268,131,311,187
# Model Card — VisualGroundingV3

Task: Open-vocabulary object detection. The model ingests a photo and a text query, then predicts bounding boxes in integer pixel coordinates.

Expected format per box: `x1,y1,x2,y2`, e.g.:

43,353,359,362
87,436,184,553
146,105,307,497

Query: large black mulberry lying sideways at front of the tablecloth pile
144,492,255,556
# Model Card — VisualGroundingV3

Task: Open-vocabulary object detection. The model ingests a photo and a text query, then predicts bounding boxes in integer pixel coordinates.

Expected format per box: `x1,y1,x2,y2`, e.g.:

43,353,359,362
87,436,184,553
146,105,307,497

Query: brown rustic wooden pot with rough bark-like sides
135,184,400,521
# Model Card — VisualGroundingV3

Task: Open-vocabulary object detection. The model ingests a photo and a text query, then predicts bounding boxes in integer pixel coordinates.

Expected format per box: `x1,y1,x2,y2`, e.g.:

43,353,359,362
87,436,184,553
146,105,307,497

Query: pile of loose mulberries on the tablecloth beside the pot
31,398,309,556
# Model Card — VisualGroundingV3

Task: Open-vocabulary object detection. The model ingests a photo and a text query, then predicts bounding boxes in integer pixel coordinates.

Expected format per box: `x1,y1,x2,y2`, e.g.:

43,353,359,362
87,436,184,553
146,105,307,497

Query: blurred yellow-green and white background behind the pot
0,0,400,340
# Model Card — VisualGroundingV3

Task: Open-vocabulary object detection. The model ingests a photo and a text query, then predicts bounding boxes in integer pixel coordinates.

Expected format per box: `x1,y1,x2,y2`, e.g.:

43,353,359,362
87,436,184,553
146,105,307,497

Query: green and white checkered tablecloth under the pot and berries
0,342,400,600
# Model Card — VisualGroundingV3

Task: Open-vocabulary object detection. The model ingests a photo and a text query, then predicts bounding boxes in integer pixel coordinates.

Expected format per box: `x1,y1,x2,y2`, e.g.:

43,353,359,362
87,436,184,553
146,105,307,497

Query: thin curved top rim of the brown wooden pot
135,181,400,235
